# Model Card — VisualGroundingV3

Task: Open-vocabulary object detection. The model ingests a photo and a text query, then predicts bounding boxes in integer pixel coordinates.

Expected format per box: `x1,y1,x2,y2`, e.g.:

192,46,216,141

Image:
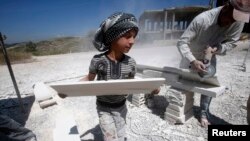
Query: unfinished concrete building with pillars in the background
139,6,210,42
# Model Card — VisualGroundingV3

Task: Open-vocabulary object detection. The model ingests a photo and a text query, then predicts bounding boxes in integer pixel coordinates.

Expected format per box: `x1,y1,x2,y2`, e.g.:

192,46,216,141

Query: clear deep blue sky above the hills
0,0,209,43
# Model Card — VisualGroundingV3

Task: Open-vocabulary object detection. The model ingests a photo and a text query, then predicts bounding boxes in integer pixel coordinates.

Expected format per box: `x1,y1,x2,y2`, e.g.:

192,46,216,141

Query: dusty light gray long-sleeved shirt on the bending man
177,7,244,62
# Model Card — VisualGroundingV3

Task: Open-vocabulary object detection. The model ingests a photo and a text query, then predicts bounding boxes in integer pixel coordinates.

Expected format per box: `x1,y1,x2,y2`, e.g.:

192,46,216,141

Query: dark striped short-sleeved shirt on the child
89,53,136,103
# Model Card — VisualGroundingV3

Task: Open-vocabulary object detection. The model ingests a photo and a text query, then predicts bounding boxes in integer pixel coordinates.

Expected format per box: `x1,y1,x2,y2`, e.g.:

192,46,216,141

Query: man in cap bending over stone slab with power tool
177,0,250,127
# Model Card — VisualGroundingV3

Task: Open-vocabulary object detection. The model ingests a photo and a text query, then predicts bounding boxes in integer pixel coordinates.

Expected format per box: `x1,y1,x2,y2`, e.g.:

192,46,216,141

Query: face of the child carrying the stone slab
111,29,136,53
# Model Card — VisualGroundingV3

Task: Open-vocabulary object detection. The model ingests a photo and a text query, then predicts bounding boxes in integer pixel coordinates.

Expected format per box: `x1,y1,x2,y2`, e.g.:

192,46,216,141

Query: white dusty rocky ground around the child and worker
0,41,250,141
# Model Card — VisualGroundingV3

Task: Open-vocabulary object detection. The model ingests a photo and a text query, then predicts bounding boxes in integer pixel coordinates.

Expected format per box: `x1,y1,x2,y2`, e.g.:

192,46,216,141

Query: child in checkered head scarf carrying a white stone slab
82,13,139,141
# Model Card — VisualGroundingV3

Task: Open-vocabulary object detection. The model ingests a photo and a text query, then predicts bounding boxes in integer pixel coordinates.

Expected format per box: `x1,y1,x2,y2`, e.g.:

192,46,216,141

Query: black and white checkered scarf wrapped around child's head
93,12,139,52
